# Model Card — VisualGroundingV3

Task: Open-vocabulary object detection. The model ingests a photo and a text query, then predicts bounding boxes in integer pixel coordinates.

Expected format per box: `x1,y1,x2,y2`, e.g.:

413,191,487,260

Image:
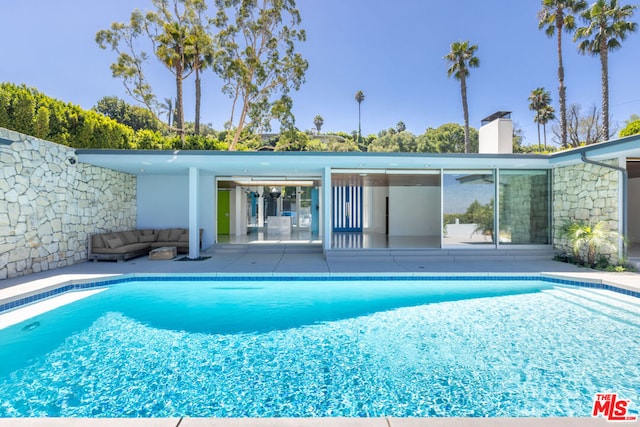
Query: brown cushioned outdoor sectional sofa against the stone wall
88,228,203,261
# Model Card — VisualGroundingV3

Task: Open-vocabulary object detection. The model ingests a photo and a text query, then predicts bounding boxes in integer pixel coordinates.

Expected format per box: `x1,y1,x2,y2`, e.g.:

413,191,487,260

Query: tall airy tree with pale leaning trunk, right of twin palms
214,0,309,150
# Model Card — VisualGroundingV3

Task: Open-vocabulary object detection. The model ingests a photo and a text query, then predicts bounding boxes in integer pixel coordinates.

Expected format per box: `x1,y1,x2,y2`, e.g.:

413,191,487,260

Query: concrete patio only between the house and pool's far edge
0,245,640,292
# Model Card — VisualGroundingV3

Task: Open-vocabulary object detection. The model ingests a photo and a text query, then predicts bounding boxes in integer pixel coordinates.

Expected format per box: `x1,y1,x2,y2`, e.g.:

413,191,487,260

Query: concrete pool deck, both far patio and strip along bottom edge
0,245,640,427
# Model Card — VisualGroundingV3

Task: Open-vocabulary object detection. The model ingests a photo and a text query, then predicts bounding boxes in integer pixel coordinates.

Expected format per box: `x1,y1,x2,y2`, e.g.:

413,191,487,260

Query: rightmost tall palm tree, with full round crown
574,0,638,140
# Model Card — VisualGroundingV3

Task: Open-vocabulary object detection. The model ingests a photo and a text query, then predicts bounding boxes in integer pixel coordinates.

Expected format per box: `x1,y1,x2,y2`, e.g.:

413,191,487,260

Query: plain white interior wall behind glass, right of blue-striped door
389,187,441,236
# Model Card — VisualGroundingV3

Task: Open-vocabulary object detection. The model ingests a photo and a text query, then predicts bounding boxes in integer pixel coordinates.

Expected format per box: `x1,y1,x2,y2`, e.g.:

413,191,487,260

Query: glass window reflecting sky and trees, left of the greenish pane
442,171,495,247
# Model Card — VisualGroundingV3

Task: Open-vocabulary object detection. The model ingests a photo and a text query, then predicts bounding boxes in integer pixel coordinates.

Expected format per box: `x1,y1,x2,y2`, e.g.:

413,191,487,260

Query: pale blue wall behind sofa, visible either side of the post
136,175,215,248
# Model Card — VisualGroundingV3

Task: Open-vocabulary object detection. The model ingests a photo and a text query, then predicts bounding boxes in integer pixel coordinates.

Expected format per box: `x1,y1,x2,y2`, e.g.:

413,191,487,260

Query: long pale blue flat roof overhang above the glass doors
76,150,550,177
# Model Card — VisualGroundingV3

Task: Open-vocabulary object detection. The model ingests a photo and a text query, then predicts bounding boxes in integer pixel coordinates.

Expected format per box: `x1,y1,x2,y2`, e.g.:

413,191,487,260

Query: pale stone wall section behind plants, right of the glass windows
553,160,620,263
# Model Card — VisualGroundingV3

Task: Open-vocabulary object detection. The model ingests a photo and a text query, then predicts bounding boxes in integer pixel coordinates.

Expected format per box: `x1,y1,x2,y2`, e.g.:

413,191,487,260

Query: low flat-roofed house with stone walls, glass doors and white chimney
0,112,640,278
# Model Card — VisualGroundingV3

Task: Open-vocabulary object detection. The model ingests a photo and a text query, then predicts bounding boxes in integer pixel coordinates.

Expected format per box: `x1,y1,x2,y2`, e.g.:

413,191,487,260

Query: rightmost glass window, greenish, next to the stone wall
499,170,549,245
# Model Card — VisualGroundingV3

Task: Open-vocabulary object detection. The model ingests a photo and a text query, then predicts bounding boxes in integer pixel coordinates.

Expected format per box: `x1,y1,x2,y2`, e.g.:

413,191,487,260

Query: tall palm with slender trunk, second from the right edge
538,0,587,147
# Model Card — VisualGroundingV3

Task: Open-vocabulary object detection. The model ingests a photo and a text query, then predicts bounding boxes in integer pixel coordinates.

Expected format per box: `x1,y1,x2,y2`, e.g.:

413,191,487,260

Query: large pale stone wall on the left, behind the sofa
0,128,136,279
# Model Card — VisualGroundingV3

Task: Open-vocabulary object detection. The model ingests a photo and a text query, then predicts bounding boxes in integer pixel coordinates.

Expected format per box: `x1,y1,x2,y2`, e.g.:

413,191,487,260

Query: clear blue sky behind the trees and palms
0,0,640,144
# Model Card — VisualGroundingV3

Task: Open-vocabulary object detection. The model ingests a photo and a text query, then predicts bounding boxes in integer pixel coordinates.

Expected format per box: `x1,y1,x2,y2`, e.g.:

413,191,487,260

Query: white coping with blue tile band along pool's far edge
0,272,640,315
